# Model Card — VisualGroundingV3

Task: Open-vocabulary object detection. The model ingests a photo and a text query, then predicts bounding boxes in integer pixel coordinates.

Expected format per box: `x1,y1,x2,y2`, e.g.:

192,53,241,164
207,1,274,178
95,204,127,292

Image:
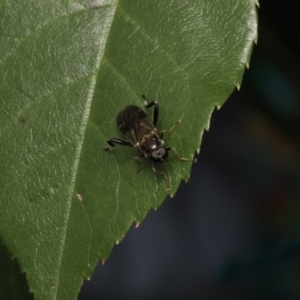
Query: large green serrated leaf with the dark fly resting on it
0,0,257,300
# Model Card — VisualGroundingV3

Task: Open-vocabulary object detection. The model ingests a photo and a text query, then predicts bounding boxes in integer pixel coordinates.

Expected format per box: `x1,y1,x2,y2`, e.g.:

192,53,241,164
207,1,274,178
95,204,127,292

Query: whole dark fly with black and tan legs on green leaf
104,95,194,190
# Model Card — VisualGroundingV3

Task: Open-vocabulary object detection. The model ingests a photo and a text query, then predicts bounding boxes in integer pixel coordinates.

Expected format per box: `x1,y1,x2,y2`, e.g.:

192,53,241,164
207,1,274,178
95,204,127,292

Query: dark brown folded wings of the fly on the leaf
117,105,156,146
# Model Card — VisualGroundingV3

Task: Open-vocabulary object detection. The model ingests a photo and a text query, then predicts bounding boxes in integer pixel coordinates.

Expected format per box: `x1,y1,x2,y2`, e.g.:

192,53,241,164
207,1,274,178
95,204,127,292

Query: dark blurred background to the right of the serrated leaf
79,0,300,300
